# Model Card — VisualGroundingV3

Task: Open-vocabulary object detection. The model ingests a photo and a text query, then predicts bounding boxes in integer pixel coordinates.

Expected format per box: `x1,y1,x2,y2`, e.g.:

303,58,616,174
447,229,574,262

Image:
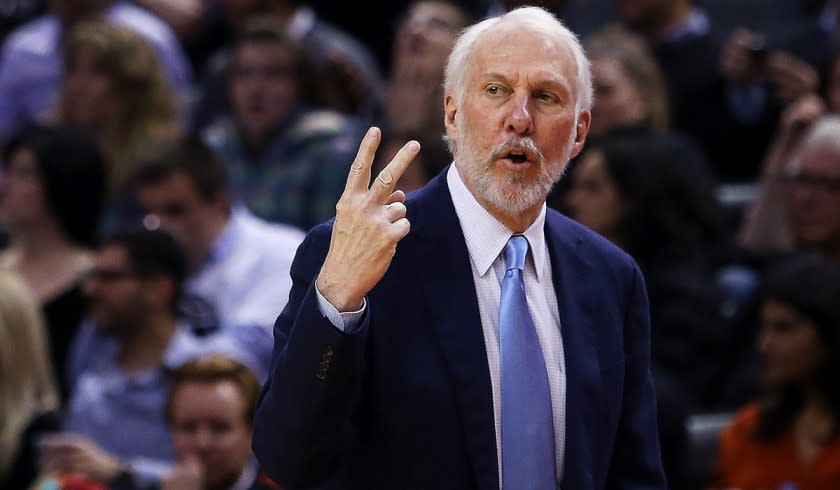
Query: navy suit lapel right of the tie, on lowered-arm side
546,211,600,490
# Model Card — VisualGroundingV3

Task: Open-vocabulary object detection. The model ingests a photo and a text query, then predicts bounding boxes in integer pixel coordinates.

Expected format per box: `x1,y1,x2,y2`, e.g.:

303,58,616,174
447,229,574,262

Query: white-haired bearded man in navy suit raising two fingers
253,7,665,490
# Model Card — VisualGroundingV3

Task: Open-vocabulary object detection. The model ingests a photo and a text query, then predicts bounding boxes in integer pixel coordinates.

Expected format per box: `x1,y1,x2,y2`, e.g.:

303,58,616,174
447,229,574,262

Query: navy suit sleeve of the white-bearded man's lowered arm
607,264,667,490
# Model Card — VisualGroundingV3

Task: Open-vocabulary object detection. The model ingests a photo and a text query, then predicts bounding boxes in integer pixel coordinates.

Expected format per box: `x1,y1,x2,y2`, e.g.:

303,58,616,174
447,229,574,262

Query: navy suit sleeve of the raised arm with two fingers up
253,225,370,488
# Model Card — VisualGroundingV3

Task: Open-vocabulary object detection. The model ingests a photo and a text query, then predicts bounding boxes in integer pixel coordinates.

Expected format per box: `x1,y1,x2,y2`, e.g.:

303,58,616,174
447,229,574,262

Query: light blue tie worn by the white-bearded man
499,235,557,490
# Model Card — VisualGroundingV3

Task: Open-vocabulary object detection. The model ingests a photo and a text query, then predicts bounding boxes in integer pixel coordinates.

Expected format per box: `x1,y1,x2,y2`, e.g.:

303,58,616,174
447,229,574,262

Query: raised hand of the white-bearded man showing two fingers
316,128,420,311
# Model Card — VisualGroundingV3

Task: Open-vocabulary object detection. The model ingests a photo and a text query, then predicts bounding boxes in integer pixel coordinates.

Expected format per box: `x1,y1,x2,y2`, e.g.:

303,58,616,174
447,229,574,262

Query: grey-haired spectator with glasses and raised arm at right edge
741,113,840,263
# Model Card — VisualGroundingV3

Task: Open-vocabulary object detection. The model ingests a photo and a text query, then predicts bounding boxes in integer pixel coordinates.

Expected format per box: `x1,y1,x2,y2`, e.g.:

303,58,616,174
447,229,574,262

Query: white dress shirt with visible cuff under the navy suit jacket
316,165,566,488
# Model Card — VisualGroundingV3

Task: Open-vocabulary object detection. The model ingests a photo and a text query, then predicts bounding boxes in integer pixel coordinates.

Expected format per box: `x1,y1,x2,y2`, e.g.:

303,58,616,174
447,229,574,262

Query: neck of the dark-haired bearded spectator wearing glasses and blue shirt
118,312,175,372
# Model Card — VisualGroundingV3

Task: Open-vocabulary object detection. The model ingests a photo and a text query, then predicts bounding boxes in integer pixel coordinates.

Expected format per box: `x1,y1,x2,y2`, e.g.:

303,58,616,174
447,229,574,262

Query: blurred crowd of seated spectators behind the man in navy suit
0,0,840,490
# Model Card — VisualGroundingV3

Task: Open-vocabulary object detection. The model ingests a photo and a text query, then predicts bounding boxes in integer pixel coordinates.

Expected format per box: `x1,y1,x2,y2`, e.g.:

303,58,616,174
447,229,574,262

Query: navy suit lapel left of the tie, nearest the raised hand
412,171,499,490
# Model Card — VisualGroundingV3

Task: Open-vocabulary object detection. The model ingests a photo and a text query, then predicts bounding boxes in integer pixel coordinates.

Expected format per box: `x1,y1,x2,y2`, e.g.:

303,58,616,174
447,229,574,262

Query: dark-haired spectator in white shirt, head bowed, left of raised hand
135,138,303,369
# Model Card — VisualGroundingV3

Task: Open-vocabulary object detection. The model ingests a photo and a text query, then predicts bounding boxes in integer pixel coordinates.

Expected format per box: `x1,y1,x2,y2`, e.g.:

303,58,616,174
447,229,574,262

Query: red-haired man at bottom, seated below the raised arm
162,355,269,490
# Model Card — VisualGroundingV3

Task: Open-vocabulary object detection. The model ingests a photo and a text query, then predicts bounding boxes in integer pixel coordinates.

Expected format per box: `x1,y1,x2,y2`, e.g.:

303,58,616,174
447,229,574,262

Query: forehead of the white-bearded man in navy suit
469,23,577,89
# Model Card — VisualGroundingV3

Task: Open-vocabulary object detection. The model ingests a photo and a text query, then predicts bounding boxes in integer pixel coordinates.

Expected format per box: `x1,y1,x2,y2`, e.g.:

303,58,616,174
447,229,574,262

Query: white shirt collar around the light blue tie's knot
446,164,546,282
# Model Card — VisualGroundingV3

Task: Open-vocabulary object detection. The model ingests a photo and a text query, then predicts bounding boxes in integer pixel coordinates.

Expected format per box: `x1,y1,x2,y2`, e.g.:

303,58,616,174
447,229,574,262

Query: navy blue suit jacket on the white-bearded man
253,172,665,490
